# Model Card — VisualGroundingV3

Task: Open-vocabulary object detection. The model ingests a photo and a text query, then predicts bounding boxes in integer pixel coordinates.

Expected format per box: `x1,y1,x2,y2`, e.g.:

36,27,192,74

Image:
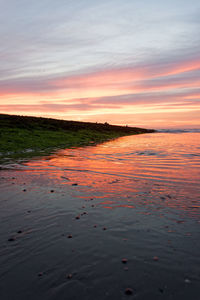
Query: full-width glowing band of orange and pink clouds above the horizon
0,55,200,127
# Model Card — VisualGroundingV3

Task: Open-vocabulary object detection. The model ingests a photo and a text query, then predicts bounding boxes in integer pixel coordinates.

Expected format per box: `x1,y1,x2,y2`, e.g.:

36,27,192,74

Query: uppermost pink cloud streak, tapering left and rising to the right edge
51,59,200,90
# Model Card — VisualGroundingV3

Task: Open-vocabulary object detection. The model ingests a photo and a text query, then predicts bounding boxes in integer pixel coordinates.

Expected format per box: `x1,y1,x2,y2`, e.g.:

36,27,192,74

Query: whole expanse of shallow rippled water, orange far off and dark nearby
0,132,200,300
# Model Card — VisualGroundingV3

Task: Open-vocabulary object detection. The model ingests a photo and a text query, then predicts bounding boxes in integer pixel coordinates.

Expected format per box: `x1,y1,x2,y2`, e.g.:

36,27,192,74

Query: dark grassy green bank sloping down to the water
0,114,155,162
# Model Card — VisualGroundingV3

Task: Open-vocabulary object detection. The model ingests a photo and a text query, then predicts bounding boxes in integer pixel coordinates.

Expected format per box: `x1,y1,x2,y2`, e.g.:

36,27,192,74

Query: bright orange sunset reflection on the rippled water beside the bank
12,133,200,215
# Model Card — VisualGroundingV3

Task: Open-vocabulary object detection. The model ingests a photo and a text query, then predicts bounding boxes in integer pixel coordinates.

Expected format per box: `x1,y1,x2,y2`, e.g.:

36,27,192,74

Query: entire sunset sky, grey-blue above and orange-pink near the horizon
0,0,200,128
